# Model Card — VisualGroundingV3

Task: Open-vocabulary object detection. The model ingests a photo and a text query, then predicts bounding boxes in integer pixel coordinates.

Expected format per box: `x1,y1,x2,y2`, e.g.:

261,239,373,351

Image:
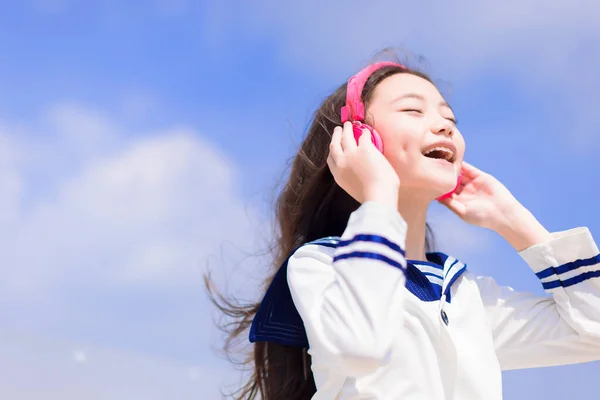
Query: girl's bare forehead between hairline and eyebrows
373,73,443,103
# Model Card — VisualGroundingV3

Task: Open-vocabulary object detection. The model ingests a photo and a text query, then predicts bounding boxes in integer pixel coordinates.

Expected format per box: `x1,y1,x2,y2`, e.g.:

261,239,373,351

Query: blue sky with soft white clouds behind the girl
0,0,600,400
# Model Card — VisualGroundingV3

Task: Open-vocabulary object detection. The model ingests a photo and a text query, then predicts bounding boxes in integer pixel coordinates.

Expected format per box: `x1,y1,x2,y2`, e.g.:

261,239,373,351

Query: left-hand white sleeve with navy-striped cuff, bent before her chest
287,202,406,376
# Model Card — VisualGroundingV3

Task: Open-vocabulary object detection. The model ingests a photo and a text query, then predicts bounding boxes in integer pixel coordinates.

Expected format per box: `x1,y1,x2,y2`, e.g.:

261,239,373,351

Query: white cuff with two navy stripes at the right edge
519,228,600,291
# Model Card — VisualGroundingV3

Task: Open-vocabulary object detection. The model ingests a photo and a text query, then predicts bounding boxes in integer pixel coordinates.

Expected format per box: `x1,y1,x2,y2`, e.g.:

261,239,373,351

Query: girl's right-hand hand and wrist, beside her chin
440,162,550,250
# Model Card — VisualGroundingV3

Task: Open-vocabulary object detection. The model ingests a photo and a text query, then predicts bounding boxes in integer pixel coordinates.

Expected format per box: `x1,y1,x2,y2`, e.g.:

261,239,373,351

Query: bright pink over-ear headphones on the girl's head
342,61,460,200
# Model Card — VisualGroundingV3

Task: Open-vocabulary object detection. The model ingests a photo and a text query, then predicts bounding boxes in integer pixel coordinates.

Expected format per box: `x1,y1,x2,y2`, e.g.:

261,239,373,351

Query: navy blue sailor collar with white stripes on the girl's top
249,237,466,347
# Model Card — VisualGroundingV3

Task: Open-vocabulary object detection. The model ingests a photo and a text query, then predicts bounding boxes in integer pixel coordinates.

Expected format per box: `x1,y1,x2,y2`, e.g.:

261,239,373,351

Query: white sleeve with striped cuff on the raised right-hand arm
477,228,600,370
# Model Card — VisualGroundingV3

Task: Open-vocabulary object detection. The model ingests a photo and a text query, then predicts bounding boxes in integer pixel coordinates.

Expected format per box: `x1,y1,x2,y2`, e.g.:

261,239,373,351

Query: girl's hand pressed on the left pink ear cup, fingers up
327,122,400,209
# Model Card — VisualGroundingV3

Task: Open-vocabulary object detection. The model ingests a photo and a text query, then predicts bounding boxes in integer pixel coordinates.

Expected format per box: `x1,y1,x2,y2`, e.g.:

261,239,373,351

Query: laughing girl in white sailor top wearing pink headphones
209,55,600,400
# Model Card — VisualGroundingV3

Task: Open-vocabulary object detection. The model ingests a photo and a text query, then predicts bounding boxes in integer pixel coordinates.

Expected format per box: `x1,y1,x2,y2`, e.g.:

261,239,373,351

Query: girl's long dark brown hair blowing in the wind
205,56,432,400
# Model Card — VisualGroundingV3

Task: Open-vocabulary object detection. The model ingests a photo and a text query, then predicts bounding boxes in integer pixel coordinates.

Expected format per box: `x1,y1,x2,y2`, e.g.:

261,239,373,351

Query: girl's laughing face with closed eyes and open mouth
366,73,465,200
